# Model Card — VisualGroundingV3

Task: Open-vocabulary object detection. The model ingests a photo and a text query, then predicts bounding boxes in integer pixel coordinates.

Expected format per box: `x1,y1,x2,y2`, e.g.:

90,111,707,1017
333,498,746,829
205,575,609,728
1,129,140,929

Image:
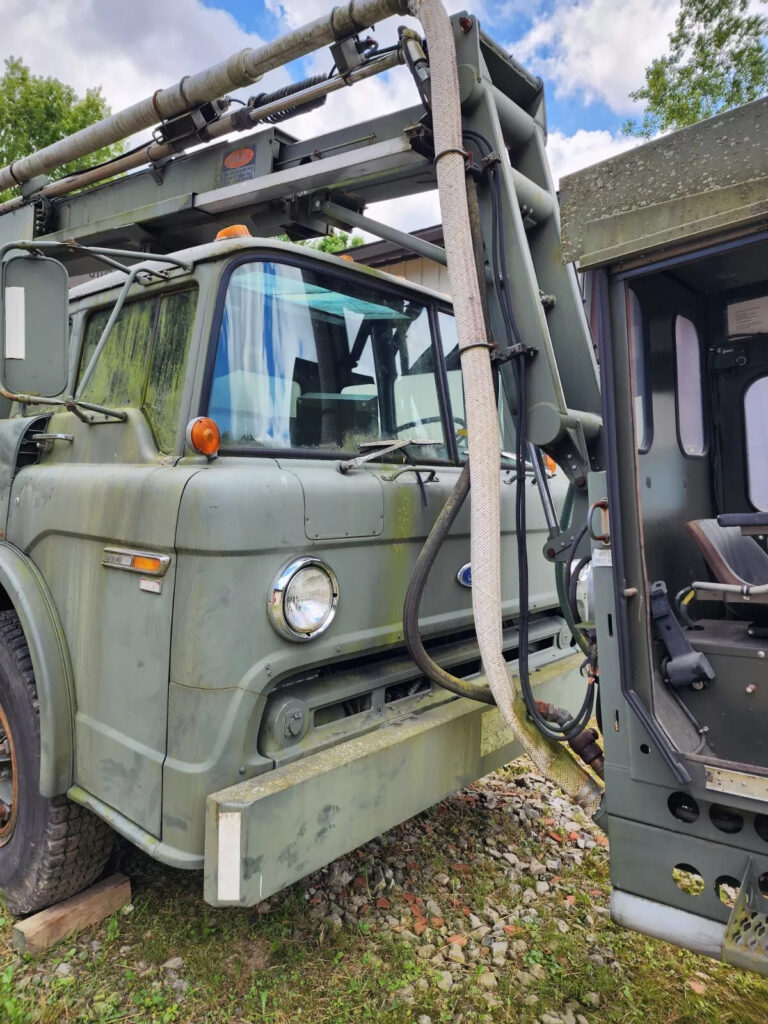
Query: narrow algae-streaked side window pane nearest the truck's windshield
144,292,198,452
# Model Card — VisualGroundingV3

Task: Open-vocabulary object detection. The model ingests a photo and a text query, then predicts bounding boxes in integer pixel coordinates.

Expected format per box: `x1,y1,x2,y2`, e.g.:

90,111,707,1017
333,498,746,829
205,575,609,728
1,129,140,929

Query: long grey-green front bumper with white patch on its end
205,658,579,906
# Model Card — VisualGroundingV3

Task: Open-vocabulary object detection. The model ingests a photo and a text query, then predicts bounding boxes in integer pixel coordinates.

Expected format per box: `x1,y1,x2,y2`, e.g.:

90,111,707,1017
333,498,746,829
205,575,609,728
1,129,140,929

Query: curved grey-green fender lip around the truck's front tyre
0,542,75,797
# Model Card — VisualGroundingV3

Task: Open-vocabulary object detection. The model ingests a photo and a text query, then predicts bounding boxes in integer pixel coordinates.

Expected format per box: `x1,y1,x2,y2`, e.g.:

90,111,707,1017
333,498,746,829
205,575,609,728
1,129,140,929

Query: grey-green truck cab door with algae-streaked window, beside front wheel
7,290,198,836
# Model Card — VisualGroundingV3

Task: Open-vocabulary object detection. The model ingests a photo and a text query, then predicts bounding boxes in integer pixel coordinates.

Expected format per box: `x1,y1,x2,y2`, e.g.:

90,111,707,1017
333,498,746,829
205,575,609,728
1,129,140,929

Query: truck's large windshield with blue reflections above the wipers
208,261,456,460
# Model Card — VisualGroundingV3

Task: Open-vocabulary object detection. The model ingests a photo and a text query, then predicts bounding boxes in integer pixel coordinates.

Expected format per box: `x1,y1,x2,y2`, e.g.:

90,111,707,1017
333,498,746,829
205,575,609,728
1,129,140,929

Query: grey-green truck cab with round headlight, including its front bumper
0,231,582,905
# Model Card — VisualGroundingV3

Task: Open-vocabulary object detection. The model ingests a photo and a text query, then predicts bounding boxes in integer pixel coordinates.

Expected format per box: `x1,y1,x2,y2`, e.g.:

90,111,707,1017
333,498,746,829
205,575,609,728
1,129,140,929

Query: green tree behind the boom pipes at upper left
0,57,123,202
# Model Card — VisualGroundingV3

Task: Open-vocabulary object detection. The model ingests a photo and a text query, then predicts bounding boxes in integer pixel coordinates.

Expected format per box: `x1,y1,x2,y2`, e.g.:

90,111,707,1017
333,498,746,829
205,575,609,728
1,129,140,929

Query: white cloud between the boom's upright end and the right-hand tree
510,0,678,114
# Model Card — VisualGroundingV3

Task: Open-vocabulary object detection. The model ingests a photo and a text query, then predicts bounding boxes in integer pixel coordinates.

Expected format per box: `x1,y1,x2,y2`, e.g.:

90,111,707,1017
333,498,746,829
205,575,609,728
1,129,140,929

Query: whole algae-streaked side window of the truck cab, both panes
78,290,197,452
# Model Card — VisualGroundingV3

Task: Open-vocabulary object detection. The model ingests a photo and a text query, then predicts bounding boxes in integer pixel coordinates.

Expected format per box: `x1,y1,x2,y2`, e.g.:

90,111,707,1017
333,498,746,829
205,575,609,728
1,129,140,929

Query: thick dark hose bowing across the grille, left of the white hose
402,463,496,703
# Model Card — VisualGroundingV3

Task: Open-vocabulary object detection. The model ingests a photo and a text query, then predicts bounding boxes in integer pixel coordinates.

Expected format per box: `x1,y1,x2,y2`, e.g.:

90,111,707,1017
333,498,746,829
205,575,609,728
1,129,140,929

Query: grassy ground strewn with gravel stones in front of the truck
0,759,768,1024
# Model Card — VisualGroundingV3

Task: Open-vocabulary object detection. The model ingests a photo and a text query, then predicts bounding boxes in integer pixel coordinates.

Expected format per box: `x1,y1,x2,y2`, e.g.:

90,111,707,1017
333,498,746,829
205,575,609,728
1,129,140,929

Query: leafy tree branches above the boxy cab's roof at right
624,0,768,138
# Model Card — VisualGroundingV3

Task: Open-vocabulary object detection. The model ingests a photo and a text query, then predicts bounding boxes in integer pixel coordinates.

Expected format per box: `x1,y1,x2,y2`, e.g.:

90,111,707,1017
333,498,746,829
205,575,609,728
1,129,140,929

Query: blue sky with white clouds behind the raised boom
0,0,678,229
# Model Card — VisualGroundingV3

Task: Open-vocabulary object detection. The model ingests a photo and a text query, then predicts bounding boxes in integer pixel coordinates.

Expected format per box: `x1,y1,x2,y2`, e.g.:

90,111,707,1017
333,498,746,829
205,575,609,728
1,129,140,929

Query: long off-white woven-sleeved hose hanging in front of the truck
410,0,602,809
